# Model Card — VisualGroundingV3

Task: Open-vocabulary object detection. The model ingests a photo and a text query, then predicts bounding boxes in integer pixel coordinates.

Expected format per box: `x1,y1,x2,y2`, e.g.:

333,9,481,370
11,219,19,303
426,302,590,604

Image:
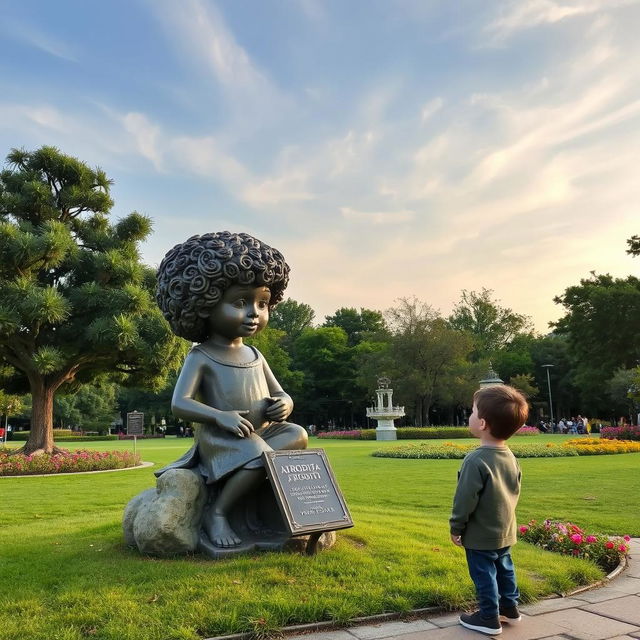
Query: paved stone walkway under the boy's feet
286,538,640,640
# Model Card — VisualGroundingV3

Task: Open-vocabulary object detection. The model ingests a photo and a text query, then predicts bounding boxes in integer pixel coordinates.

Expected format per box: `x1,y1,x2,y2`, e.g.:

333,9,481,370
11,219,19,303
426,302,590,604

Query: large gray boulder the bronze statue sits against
122,469,207,556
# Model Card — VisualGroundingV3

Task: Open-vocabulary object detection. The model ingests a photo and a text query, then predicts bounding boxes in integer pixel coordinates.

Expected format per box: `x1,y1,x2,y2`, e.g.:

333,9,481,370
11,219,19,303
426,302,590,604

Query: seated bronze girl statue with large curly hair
156,231,307,547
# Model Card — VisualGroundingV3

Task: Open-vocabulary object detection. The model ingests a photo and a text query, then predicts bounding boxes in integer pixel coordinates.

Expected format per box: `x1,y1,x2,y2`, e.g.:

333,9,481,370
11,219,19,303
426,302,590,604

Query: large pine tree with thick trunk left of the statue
0,147,187,453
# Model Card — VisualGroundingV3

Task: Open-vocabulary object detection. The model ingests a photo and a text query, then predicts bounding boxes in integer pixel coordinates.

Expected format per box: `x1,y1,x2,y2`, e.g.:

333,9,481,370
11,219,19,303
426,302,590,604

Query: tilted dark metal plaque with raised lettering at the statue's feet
262,449,353,536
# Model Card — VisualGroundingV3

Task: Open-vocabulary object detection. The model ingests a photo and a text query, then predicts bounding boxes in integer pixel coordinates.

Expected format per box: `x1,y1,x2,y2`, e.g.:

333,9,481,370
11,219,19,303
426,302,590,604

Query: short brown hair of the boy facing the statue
473,384,529,440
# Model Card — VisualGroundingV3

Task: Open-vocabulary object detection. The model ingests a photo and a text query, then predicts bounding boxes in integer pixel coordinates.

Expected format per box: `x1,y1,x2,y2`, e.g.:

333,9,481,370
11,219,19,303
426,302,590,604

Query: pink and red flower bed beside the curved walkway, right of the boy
518,520,631,573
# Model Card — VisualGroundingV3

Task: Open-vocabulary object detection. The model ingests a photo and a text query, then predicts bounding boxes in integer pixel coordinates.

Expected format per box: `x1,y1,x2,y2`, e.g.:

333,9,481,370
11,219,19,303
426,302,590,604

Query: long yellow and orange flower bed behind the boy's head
371,438,640,460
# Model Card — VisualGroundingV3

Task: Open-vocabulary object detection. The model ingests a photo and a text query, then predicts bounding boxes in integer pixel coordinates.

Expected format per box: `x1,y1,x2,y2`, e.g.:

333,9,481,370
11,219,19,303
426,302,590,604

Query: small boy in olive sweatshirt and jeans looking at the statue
449,385,529,635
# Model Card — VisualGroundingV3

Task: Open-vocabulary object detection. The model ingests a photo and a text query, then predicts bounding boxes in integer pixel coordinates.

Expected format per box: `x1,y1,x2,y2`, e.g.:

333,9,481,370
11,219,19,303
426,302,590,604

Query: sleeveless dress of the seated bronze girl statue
155,345,306,484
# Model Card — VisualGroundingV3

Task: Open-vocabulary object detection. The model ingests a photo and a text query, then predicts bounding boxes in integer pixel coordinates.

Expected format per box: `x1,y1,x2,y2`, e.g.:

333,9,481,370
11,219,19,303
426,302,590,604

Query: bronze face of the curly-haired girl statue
208,285,271,340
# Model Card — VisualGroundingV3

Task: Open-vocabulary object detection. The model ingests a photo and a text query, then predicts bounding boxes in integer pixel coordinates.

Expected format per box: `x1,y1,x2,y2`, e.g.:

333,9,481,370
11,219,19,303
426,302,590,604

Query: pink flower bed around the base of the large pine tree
0,447,141,476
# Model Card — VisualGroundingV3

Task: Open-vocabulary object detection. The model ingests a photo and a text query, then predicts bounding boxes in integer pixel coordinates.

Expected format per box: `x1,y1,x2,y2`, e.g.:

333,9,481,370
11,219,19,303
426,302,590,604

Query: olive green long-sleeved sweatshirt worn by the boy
449,446,522,550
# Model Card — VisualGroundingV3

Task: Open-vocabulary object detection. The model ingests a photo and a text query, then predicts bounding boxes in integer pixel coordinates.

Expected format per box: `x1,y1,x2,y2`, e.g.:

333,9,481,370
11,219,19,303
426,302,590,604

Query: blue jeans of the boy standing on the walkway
465,547,520,618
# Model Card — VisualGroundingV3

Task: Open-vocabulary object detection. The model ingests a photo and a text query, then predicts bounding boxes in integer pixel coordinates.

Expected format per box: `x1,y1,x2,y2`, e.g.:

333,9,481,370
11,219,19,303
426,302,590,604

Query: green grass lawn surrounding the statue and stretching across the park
0,436,640,640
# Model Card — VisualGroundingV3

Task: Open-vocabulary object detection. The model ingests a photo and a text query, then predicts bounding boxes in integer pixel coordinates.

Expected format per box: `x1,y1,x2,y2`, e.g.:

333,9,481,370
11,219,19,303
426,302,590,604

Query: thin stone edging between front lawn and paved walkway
204,544,629,640
